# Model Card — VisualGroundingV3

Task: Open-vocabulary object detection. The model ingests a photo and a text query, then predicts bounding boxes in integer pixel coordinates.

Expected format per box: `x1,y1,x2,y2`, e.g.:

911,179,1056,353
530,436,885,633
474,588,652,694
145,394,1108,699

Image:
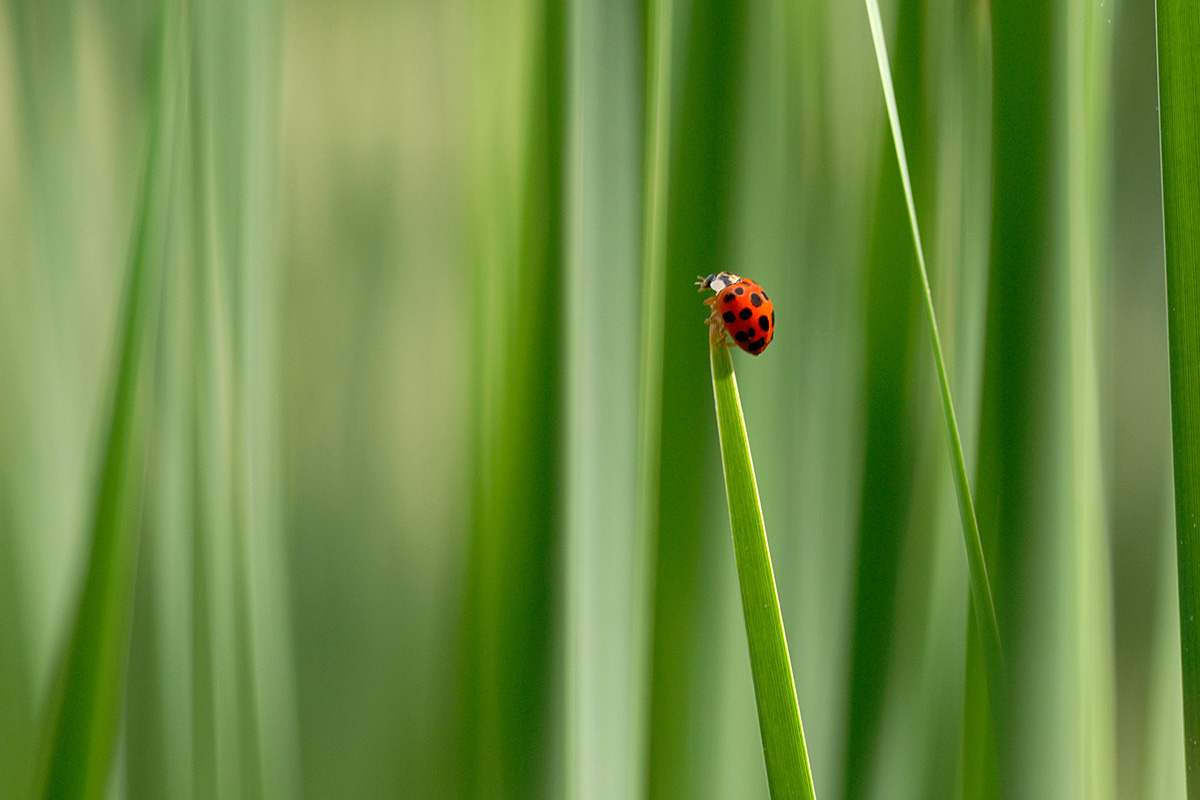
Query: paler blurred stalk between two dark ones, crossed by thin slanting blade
901,2,998,800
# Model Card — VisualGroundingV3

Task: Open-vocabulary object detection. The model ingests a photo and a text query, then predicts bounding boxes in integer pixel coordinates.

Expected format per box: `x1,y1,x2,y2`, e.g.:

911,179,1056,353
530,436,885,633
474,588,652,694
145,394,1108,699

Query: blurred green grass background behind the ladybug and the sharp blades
0,0,1183,800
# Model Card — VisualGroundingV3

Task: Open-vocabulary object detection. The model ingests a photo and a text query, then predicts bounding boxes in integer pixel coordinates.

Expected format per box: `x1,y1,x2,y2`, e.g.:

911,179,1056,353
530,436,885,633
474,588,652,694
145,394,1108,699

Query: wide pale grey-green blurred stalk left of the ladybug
564,0,661,798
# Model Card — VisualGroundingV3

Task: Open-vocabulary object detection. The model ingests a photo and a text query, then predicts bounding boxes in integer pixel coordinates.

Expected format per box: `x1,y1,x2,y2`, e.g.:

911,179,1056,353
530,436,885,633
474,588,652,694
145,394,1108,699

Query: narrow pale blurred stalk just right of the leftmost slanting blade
187,4,248,800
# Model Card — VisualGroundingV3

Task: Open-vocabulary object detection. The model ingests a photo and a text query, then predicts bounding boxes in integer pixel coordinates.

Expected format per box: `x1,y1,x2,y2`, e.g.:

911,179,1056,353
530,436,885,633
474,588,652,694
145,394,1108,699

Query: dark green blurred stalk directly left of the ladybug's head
648,0,748,800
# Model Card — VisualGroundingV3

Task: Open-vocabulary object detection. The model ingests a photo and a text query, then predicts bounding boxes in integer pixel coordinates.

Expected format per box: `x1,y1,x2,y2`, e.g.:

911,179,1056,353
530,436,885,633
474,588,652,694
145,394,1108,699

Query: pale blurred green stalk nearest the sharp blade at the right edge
1065,0,1116,800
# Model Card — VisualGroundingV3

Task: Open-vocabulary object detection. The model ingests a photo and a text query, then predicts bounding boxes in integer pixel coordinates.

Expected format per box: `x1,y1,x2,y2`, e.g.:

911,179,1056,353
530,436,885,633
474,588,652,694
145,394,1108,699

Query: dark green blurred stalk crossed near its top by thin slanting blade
844,0,921,786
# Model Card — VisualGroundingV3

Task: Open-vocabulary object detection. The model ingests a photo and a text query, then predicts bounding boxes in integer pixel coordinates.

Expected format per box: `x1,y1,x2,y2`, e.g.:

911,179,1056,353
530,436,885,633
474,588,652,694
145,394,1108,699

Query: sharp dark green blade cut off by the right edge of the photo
1157,0,1200,798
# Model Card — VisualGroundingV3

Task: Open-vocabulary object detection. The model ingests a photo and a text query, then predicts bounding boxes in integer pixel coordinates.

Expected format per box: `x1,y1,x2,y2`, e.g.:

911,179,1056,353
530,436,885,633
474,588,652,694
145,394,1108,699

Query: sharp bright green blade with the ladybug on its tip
710,343,816,800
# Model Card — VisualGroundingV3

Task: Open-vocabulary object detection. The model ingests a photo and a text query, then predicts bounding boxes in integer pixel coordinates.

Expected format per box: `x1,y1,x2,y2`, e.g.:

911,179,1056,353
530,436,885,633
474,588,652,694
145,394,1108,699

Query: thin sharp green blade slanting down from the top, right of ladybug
865,0,1004,708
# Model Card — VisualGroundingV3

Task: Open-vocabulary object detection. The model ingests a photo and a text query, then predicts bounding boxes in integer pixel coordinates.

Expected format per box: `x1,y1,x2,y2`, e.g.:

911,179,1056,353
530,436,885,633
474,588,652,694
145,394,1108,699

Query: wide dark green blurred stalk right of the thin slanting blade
968,4,1051,796
